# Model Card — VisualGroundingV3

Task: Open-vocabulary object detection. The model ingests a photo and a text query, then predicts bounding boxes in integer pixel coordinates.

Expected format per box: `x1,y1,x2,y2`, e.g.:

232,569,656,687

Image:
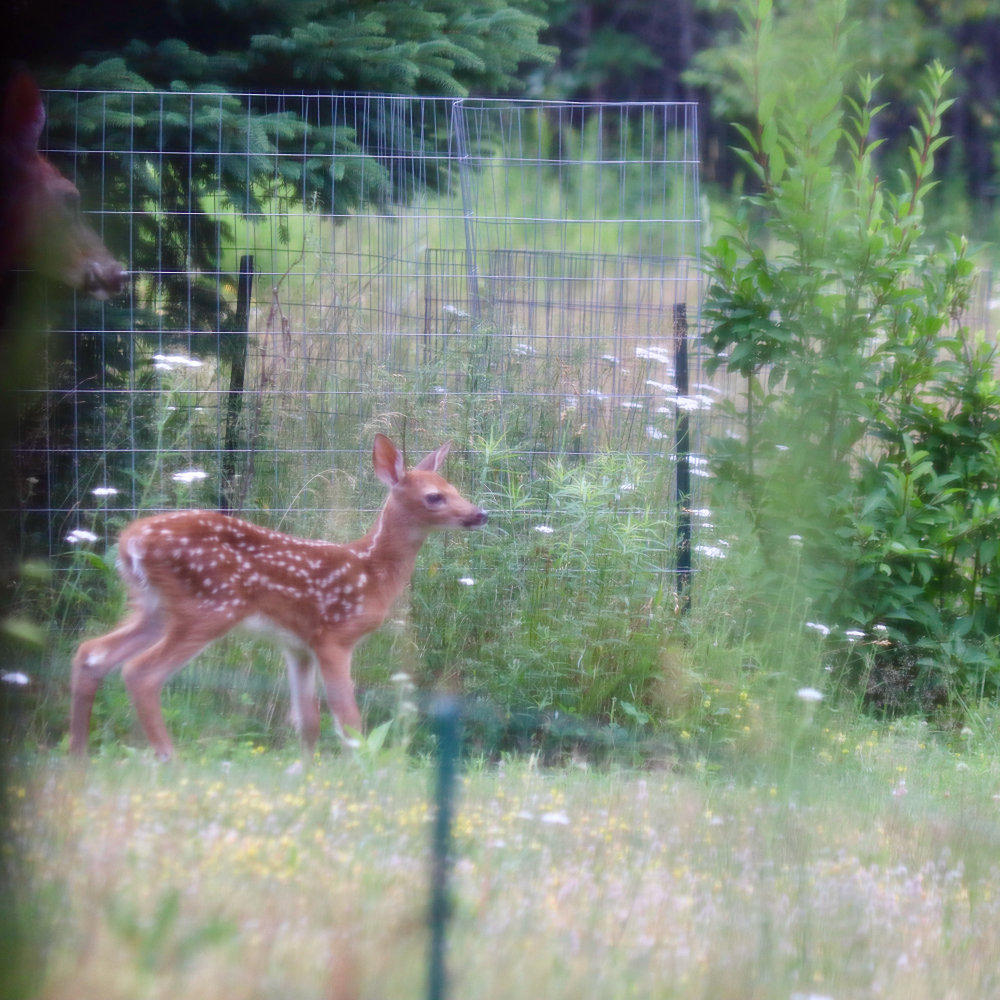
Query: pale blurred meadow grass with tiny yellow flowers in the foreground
7,713,1000,1000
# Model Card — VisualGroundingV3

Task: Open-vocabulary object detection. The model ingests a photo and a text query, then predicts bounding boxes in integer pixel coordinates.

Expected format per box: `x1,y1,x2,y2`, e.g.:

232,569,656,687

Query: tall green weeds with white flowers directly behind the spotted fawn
7,300,867,759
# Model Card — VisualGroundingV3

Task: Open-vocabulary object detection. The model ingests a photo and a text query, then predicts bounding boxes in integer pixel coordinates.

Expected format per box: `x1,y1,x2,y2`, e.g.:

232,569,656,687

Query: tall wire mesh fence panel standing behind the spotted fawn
16,92,707,584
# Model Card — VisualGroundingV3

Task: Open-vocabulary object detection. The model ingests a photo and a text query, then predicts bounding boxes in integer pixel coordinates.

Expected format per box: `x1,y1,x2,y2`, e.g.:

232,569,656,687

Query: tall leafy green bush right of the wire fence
706,0,1000,708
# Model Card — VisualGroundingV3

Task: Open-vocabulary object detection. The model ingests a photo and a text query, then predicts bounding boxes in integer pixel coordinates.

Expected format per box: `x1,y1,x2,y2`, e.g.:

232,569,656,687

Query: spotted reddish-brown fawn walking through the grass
70,434,486,759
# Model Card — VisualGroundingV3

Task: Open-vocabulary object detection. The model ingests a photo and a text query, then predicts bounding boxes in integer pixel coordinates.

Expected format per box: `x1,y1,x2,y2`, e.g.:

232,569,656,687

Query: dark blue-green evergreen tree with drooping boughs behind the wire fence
0,0,553,548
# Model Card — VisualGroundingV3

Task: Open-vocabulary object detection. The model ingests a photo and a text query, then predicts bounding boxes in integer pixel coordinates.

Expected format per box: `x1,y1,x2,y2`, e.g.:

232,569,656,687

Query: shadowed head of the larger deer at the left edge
0,73,125,299
